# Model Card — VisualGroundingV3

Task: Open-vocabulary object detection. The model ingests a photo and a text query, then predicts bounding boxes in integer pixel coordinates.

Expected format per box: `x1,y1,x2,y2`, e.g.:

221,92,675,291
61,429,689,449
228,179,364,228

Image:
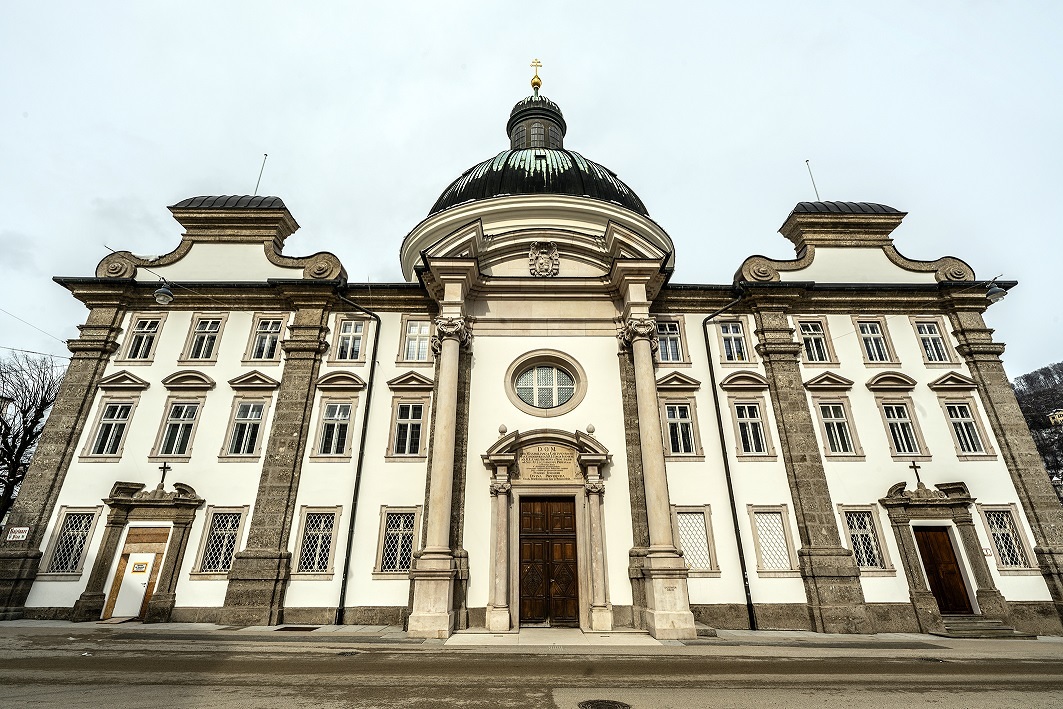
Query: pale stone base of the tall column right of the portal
642,554,697,640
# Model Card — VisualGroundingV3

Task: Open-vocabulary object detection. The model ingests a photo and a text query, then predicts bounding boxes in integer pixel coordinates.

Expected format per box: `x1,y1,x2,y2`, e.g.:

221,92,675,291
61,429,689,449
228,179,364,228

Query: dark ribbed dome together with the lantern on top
428,93,649,217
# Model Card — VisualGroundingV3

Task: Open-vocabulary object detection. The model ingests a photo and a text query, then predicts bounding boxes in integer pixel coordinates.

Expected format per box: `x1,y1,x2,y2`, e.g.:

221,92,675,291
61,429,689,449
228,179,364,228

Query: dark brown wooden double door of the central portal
520,497,579,626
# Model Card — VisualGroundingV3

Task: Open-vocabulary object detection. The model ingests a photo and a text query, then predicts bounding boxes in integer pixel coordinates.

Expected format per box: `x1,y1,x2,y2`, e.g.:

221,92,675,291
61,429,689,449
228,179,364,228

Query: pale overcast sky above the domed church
0,0,1063,376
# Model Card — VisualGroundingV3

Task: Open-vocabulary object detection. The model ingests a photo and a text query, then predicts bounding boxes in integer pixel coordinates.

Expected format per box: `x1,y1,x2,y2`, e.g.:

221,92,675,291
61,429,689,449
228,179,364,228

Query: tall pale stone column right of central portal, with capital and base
622,317,696,639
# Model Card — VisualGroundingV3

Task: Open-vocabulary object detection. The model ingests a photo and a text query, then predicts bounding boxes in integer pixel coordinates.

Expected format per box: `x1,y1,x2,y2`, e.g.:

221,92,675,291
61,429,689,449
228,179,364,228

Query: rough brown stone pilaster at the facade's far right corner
949,301,1063,619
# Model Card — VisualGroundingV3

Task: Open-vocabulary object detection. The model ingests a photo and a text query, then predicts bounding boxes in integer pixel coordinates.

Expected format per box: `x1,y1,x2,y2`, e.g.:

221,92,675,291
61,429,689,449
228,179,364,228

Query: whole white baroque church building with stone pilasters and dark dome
0,77,1063,639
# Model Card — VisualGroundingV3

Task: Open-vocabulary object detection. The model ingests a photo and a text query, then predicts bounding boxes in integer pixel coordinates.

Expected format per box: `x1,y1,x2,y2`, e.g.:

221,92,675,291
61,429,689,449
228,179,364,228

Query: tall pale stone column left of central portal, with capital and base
407,316,469,638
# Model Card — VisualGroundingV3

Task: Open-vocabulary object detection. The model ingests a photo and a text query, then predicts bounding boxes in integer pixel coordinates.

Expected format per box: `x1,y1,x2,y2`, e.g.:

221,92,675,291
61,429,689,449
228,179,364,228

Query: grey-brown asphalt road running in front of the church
0,632,1063,709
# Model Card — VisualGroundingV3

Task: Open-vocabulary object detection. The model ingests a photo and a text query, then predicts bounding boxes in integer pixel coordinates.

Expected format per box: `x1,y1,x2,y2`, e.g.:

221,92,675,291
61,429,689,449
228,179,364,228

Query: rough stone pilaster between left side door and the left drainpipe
220,293,327,625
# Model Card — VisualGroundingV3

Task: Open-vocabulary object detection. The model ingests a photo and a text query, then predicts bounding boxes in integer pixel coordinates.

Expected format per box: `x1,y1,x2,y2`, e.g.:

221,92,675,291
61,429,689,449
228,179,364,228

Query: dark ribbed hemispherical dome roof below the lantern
428,148,649,216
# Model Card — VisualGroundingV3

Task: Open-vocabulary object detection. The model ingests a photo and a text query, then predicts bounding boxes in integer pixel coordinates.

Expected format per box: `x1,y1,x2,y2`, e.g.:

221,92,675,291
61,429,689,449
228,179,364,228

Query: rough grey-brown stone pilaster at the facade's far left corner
0,283,128,621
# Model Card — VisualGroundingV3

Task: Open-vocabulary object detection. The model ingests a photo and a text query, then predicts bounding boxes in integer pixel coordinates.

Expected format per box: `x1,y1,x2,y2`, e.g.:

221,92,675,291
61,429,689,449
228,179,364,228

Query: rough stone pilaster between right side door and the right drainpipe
754,302,872,632
